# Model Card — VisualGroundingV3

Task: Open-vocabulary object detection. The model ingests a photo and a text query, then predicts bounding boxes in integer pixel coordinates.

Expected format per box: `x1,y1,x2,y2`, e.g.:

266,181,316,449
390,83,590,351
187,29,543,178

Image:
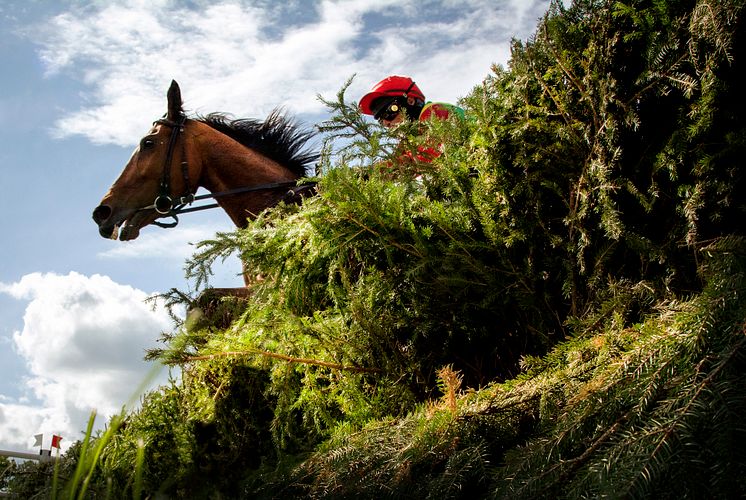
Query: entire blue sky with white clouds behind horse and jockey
0,0,549,452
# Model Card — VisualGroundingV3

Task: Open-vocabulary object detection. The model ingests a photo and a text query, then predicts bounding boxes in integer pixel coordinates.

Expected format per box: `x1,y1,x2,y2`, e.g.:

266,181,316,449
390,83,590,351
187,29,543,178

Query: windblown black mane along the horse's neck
196,109,320,177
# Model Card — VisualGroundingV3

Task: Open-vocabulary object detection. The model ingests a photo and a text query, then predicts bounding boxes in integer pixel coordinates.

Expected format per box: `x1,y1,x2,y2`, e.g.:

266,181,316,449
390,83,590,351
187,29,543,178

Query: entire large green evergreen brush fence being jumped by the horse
8,0,746,498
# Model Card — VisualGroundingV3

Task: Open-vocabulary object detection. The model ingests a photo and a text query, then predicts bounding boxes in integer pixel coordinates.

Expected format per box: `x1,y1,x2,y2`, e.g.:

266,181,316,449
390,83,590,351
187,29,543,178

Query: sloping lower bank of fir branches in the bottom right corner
270,238,746,499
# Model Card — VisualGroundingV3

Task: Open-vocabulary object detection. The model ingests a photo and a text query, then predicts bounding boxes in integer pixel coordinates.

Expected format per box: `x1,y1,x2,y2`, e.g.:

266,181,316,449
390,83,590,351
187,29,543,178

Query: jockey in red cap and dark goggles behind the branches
359,75,464,127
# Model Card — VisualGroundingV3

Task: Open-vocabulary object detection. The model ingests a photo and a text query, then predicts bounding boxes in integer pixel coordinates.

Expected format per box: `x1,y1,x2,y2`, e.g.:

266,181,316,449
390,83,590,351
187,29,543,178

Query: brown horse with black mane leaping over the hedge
93,81,319,241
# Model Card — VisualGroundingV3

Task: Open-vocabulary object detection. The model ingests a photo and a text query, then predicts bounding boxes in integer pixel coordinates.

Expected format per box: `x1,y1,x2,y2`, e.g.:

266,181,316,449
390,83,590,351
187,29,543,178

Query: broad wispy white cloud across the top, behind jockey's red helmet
35,0,548,145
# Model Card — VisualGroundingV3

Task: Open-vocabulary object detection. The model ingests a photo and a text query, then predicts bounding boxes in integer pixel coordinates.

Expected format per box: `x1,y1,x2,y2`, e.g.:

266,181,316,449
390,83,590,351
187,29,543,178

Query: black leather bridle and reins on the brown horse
138,115,316,228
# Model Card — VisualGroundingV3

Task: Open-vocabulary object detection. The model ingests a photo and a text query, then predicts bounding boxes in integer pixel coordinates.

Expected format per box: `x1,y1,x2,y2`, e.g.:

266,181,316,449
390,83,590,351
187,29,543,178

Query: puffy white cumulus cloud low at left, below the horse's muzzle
0,272,172,450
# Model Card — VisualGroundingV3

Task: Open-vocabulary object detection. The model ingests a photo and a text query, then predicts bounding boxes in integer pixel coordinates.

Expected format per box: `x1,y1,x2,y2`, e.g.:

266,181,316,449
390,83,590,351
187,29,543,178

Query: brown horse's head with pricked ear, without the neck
93,81,199,241
